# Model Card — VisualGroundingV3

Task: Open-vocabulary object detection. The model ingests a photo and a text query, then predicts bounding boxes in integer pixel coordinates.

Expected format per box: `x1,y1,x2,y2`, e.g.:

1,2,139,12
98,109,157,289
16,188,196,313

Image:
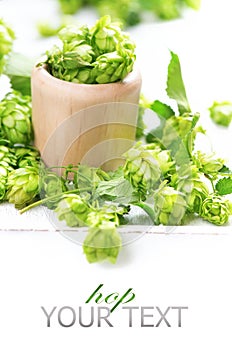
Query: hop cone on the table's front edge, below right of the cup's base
154,182,187,226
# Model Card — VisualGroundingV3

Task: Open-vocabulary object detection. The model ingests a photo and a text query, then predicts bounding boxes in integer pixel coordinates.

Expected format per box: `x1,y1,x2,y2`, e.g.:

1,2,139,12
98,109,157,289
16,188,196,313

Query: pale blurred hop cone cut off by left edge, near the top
0,18,15,74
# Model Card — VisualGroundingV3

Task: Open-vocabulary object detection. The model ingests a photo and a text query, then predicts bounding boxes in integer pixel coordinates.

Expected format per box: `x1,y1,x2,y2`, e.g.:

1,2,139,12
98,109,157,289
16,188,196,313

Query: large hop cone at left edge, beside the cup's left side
0,91,32,145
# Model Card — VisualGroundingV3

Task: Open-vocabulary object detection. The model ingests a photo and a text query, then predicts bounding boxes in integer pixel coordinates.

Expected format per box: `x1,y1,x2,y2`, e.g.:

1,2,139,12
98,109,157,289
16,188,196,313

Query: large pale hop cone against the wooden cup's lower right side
123,143,161,195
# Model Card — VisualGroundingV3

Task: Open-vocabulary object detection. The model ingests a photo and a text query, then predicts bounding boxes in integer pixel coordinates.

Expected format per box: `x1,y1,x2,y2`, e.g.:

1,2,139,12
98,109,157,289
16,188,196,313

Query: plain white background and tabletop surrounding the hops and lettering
0,0,232,350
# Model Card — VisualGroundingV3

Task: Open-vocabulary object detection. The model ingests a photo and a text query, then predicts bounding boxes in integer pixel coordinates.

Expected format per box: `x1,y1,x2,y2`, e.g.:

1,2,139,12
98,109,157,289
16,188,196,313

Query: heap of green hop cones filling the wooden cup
44,16,135,84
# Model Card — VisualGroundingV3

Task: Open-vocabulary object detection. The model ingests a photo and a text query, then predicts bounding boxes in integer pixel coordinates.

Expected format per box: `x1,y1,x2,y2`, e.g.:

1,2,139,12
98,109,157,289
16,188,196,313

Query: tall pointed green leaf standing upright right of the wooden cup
166,51,191,114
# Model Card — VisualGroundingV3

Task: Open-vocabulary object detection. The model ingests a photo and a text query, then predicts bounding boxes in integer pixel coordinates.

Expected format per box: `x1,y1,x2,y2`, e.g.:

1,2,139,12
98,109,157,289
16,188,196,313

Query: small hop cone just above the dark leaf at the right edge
194,151,225,176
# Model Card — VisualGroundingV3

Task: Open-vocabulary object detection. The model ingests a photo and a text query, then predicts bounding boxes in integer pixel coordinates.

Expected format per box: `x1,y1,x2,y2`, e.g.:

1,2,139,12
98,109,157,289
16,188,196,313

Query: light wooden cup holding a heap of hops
32,66,142,170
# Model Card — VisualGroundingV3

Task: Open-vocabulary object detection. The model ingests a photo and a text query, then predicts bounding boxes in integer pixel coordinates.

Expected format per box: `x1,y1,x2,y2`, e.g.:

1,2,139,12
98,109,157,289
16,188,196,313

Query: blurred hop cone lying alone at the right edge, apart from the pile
209,101,232,126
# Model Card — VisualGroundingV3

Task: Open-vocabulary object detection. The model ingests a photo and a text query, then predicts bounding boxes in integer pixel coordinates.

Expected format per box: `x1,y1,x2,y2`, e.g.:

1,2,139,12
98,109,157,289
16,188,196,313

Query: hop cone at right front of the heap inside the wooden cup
92,43,135,84
